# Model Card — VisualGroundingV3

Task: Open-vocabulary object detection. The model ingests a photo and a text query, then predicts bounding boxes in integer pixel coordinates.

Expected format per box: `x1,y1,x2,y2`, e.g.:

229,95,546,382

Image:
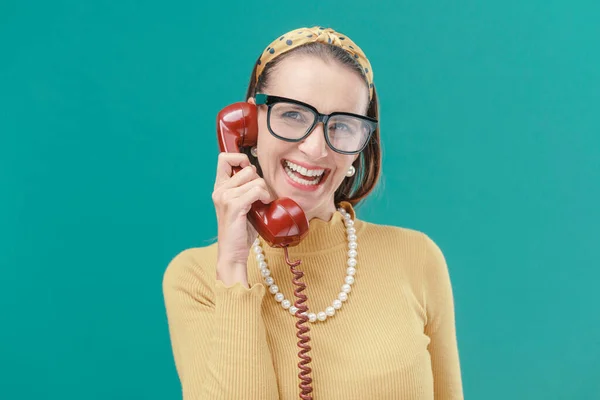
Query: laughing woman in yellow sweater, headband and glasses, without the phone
164,27,463,400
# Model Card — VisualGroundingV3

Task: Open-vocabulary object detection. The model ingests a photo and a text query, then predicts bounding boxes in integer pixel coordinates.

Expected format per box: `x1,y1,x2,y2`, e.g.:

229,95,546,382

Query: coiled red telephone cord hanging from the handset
283,247,313,400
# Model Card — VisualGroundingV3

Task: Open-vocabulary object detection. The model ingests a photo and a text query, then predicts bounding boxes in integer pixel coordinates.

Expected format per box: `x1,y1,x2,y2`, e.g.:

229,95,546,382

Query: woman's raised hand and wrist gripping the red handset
212,152,274,287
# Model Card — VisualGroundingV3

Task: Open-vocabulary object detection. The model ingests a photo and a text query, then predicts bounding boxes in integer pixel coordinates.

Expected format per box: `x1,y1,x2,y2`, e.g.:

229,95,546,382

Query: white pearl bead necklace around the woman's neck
252,208,358,323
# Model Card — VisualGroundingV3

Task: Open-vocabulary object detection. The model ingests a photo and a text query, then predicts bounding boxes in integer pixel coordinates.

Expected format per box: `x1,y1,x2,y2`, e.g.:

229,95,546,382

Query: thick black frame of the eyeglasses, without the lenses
254,93,378,154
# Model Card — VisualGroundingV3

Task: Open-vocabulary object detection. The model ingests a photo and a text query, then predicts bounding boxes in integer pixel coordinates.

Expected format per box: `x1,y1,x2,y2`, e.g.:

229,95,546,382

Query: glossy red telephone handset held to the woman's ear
217,102,308,247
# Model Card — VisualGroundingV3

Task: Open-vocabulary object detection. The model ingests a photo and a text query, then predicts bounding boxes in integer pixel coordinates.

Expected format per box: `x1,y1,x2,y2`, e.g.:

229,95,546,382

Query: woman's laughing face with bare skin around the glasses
249,55,369,220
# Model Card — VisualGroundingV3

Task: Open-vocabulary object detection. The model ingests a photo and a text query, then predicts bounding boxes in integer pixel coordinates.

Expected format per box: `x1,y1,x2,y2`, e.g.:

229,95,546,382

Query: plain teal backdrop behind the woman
0,0,600,400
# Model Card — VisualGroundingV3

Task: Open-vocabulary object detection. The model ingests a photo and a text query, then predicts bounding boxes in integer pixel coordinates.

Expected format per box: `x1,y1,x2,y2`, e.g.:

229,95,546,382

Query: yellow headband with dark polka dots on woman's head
256,26,373,99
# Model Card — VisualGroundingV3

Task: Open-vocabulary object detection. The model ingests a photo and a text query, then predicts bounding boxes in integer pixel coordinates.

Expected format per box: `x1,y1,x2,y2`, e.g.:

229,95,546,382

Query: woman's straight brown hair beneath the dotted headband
242,42,381,206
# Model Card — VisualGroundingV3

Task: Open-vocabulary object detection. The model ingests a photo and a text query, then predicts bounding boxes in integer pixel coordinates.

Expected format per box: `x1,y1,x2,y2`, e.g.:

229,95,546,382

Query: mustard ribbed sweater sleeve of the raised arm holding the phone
163,250,278,400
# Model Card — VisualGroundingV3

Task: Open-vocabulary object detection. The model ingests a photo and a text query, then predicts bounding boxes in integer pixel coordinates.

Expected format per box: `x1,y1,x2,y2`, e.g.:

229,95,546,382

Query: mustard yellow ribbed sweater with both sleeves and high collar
163,204,463,400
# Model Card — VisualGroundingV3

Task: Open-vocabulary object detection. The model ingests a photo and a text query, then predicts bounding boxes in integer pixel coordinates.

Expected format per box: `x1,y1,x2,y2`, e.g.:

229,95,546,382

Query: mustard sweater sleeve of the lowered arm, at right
424,236,464,400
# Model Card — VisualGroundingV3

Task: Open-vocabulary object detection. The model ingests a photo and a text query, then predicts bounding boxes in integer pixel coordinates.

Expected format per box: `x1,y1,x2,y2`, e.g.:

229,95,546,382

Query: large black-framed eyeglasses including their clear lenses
255,93,377,154
